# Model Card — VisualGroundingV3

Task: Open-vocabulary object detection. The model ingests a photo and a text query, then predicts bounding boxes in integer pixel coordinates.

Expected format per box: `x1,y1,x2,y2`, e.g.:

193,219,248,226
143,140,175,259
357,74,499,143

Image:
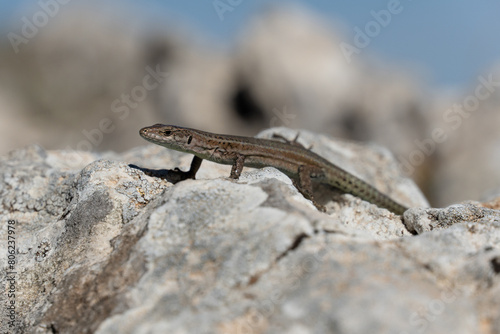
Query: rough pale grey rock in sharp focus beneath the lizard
0,129,500,333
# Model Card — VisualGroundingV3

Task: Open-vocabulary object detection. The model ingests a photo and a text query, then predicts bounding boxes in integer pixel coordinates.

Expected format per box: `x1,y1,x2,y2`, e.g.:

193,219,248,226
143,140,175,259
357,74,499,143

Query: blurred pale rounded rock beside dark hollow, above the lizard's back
233,5,429,149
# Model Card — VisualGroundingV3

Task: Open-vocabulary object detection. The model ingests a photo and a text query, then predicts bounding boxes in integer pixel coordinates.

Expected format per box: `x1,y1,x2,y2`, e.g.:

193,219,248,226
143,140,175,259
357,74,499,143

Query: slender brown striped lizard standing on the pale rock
139,124,408,215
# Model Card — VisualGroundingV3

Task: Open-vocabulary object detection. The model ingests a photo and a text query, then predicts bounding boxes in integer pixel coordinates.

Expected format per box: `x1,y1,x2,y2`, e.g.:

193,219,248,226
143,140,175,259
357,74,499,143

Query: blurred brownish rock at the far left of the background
0,7,163,154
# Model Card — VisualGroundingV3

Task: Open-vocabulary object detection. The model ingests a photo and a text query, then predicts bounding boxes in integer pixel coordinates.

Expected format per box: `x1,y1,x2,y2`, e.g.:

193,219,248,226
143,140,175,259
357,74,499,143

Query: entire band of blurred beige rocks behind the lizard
0,6,500,206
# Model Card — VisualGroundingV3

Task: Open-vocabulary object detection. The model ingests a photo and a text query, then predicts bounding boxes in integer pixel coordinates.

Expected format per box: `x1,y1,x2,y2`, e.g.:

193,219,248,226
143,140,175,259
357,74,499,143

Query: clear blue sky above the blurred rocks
0,0,500,87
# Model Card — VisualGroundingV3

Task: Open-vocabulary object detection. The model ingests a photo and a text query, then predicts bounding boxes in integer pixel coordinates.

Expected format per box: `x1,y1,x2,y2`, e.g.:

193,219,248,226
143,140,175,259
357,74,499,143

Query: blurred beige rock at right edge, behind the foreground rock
429,68,500,205
